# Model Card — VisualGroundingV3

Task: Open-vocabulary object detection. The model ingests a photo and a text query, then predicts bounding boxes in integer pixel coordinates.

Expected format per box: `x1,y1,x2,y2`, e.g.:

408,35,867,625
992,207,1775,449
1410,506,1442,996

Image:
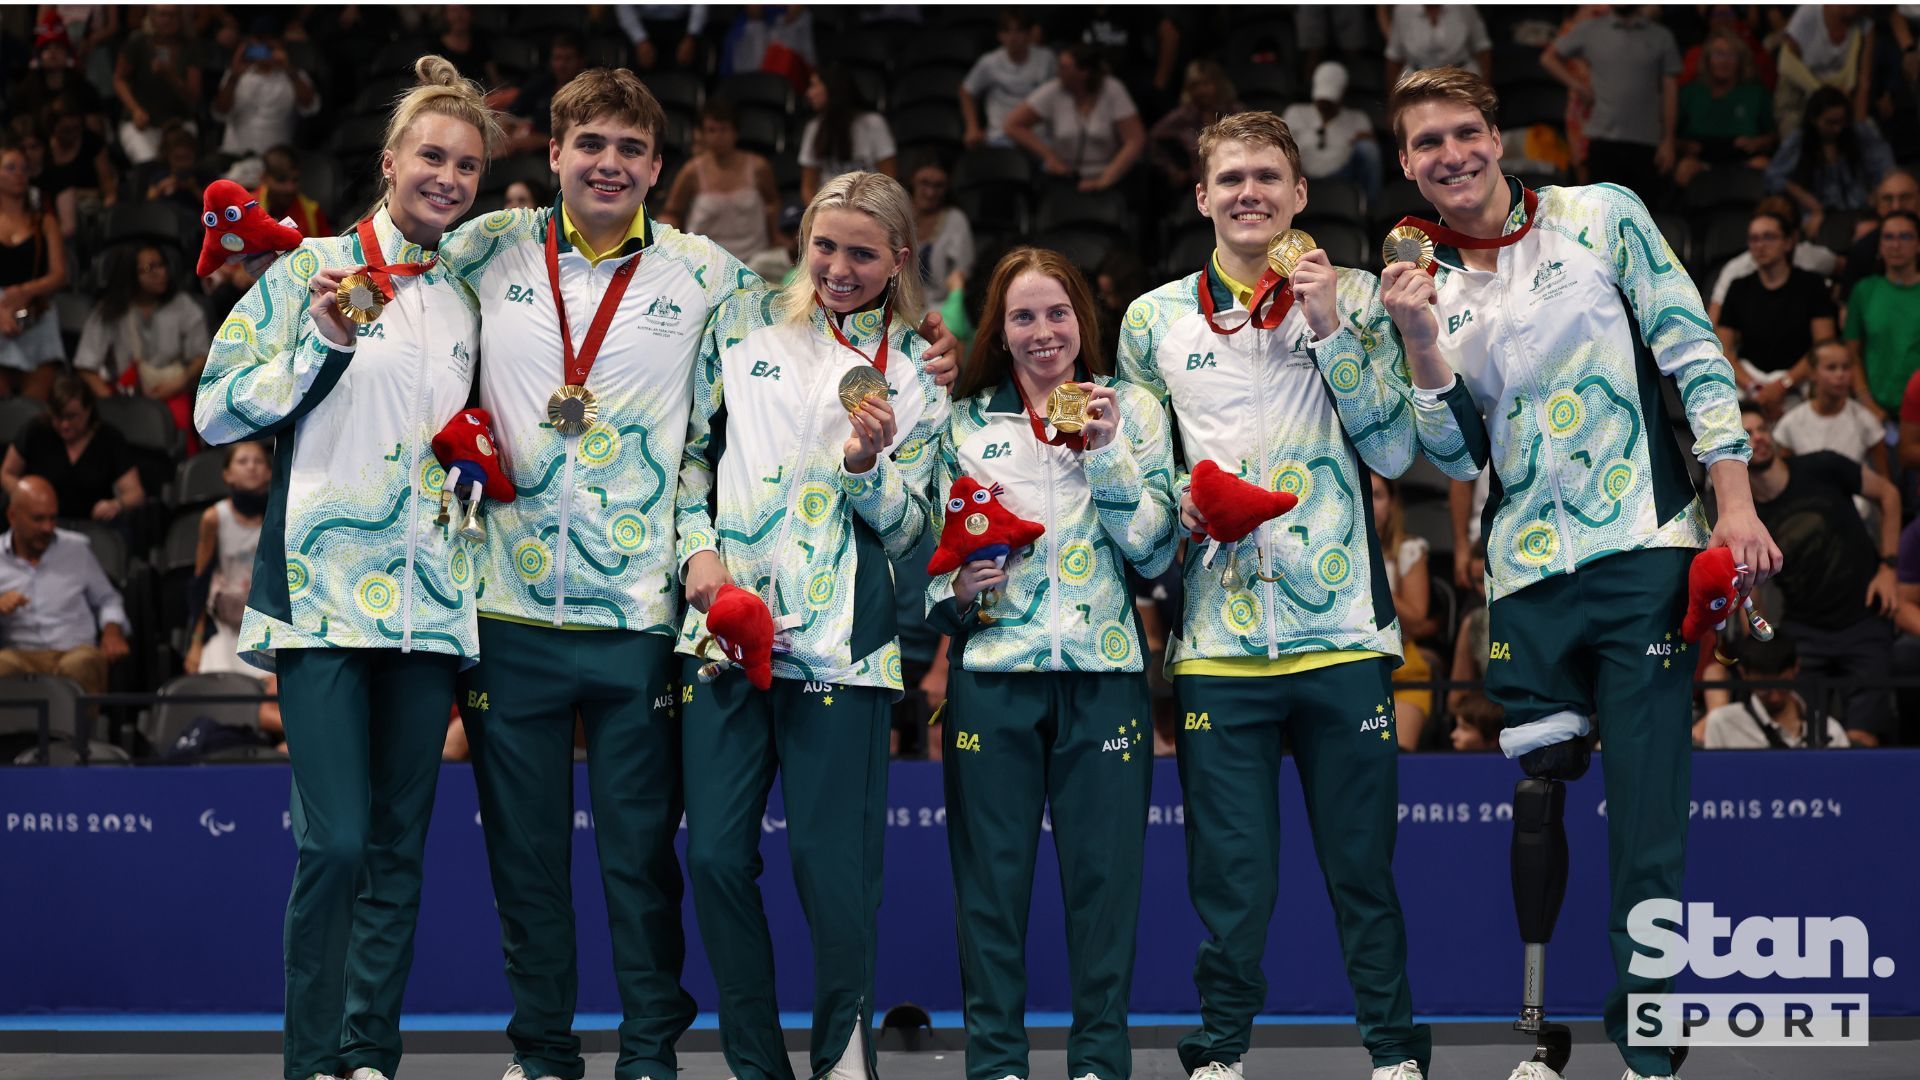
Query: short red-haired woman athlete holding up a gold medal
927,248,1175,1080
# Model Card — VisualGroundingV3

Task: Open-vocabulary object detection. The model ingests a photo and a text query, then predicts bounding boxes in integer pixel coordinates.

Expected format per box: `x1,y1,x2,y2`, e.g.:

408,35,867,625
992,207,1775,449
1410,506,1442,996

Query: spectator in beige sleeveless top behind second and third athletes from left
660,98,787,263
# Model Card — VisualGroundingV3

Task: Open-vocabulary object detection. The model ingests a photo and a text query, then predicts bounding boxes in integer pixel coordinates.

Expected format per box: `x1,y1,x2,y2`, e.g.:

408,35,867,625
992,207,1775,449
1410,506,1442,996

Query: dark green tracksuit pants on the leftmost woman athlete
276,650,459,1080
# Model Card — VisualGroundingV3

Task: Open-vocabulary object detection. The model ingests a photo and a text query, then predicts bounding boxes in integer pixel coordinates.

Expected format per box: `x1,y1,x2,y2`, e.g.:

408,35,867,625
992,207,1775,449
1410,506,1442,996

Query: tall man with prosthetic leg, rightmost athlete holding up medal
1380,67,1780,1080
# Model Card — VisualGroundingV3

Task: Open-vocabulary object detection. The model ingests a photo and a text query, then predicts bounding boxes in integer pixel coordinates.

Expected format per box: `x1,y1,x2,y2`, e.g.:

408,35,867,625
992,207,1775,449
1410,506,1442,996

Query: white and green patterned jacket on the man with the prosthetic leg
1434,179,1751,601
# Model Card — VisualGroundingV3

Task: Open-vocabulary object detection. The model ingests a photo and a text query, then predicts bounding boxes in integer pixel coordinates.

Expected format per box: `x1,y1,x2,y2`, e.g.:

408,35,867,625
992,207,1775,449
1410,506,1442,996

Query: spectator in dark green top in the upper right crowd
1674,29,1780,186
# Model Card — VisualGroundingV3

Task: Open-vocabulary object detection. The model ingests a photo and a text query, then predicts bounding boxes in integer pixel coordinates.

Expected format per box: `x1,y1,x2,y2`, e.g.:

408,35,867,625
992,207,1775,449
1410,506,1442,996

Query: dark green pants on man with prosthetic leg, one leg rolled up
1486,548,1697,1076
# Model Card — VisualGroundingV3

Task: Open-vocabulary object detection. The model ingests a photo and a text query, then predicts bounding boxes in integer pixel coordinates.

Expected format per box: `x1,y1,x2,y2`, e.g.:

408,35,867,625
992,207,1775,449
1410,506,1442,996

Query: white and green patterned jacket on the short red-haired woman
927,377,1179,671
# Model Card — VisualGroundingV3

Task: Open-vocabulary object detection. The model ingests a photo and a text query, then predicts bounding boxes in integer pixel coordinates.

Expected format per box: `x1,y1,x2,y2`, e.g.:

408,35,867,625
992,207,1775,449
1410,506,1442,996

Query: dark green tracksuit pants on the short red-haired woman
943,669,1154,1080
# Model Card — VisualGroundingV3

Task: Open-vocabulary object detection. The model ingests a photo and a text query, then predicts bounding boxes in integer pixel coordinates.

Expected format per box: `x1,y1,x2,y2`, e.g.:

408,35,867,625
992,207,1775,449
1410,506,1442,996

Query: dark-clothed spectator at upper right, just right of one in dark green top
1766,86,1893,236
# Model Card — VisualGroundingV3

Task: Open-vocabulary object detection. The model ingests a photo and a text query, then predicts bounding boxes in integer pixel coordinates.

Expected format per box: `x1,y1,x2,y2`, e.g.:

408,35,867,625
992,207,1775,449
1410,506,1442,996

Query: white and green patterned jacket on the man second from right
1119,267,1471,665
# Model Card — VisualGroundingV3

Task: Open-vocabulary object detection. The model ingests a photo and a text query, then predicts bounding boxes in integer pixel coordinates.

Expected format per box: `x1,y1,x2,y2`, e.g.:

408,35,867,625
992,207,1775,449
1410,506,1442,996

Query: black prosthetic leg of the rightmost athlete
1513,738,1592,1080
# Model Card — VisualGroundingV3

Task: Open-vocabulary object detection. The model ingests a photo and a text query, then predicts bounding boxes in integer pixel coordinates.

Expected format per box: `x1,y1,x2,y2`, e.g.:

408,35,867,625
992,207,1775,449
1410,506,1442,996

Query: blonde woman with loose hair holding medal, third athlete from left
678,173,947,1080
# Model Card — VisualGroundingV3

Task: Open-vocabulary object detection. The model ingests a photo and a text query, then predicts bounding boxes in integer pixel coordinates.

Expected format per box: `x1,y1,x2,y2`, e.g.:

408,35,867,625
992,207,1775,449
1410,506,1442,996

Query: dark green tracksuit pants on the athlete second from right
1173,659,1432,1072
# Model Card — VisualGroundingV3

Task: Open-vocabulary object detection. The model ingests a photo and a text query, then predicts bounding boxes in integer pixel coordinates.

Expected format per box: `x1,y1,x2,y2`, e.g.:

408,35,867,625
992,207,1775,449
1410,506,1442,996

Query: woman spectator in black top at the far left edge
0,146,67,398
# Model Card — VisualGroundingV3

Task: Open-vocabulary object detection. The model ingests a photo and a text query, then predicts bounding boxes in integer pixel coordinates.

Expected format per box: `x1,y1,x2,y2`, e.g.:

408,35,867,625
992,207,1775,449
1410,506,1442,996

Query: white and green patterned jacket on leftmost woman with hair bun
194,209,480,669
